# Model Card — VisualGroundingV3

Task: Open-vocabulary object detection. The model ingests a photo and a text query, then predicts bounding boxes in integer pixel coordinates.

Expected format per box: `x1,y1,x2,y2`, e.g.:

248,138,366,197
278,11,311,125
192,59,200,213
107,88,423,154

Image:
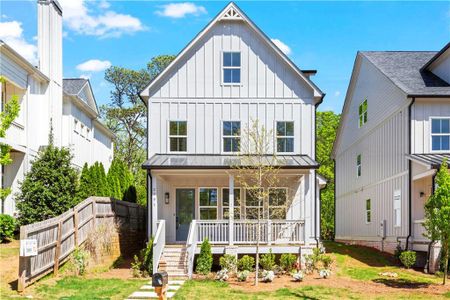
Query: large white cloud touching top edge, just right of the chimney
60,0,147,38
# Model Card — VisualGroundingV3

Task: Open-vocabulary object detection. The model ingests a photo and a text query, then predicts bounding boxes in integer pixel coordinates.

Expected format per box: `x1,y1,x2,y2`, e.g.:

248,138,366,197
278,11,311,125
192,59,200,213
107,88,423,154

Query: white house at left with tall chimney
0,0,114,215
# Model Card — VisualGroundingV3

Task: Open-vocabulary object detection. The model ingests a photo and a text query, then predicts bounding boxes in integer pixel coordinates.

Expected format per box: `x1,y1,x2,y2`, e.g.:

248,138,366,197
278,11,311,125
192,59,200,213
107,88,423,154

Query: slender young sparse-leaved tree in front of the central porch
230,121,289,285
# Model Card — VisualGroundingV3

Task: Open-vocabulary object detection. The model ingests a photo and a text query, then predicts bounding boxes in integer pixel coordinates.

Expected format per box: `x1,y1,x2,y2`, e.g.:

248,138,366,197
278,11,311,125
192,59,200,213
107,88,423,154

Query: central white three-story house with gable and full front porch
141,3,324,275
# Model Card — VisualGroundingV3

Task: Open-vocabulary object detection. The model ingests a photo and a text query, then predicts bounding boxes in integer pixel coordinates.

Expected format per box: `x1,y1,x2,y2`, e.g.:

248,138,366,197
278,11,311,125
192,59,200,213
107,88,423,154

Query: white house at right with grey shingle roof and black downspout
333,44,450,271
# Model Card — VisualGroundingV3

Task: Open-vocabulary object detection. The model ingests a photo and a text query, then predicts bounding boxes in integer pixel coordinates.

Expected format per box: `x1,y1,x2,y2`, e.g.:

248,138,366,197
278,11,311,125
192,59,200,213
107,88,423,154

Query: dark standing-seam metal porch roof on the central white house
142,154,319,170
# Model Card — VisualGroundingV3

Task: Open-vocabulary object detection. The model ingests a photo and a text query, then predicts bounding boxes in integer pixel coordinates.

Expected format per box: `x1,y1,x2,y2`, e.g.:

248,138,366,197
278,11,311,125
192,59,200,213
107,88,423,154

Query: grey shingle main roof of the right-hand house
361,51,450,96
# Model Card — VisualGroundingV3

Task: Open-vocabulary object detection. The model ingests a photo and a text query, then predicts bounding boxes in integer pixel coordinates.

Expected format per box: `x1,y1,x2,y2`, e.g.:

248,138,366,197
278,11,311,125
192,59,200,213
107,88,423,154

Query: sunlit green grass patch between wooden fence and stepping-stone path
37,277,146,300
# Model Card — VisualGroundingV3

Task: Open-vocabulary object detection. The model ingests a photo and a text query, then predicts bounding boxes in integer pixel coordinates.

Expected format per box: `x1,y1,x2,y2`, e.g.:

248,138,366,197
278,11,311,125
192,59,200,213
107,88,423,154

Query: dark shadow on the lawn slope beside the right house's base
324,242,398,267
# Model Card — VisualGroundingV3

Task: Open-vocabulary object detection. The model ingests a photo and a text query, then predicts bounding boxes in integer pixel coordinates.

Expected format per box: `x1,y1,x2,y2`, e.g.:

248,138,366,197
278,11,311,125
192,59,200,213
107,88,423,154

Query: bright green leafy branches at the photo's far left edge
0,76,20,212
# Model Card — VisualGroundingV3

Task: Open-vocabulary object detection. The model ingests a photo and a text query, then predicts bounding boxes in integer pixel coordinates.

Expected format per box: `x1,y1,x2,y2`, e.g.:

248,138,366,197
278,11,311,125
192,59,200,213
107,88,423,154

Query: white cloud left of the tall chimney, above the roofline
0,21,38,65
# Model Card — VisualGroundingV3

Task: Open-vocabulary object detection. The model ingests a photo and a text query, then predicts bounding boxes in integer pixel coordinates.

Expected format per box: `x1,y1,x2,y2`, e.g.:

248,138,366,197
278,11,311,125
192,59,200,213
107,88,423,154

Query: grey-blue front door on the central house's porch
175,189,195,241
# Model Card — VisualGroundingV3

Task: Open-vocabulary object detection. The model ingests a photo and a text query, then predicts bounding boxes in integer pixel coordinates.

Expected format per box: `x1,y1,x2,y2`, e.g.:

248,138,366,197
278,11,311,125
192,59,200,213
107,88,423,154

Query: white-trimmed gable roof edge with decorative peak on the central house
139,2,325,104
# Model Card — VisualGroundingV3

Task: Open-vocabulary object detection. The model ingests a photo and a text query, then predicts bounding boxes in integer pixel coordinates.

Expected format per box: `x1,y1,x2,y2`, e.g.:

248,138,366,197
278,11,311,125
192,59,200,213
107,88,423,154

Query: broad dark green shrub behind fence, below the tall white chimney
16,131,78,225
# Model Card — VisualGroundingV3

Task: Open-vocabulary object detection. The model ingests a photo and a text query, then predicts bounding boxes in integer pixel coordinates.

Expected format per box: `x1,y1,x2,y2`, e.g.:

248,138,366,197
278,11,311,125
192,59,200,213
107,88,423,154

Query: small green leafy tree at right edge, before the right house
424,160,450,284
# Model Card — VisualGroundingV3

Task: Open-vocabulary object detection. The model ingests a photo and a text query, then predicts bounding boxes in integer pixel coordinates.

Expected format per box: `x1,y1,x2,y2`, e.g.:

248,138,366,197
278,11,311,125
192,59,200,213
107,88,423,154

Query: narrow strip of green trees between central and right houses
316,111,340,240
